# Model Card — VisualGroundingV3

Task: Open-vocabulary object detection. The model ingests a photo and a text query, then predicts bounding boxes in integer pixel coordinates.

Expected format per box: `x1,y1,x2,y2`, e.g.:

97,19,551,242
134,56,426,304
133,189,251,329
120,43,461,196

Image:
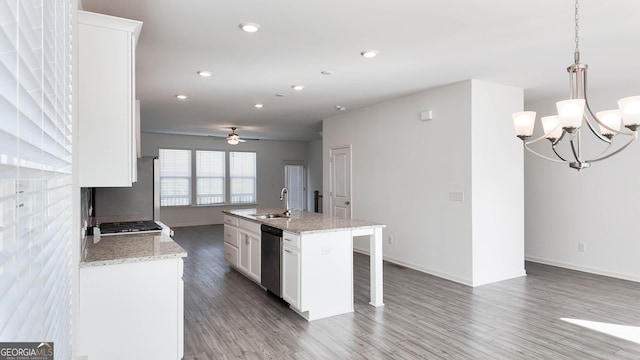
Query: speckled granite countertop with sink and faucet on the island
222,208,386,234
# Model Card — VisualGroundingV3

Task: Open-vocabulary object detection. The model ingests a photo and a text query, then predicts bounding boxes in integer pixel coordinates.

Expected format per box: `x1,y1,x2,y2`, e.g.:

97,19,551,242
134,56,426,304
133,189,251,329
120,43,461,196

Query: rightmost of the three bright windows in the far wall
229,152,256,204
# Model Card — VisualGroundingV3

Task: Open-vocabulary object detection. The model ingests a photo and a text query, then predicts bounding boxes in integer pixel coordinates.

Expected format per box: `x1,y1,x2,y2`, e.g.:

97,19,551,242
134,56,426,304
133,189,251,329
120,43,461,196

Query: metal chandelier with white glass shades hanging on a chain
513,0,640,171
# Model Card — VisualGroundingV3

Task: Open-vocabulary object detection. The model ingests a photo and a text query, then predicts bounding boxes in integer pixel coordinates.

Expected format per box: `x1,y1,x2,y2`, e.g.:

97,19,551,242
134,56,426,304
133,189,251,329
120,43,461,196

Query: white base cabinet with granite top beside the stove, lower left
78,226,187,360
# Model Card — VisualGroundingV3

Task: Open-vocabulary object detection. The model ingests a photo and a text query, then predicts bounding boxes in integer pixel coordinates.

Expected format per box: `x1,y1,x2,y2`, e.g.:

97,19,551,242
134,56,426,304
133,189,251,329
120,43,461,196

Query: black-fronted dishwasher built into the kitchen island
260,224,282,297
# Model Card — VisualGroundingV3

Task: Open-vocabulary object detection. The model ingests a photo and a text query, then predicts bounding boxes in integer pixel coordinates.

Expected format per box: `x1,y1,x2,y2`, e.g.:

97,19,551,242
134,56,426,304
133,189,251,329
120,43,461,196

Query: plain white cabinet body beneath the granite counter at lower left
78,258,184,360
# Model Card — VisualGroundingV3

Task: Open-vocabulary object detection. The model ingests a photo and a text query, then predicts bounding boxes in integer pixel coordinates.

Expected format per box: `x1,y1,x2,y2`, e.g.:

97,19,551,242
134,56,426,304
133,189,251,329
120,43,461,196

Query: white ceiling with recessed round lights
81,0,640,141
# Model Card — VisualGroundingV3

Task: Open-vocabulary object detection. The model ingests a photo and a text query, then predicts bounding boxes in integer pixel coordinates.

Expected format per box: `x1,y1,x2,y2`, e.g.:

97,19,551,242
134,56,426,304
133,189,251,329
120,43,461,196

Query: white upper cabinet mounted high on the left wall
74,11,142,187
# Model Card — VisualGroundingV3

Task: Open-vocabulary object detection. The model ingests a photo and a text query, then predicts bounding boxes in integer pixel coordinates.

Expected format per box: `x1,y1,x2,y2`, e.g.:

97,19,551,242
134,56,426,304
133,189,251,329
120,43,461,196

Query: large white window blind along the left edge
0,0,72,359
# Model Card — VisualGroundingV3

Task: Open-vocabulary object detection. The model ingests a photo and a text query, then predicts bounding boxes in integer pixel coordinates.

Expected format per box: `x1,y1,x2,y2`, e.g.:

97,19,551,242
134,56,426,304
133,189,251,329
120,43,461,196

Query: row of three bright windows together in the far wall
159,149,256,206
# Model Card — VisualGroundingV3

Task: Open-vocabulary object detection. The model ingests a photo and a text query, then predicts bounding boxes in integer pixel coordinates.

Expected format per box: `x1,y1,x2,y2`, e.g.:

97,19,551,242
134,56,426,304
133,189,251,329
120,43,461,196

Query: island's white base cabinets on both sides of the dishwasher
224,215,353,321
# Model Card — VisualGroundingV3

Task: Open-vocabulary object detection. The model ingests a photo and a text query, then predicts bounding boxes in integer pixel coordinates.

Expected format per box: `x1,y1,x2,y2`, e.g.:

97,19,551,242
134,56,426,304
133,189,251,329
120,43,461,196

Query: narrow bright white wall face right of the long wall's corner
471,80,525,286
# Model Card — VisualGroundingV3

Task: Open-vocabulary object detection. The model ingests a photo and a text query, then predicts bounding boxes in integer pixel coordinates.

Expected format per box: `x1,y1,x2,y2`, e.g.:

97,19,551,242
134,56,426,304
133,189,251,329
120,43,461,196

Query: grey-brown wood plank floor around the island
174,225,640,360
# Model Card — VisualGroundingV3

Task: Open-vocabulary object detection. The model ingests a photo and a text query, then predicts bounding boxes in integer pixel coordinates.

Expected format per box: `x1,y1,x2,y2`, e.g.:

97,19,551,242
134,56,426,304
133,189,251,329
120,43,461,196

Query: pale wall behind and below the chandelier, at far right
525,85,640,281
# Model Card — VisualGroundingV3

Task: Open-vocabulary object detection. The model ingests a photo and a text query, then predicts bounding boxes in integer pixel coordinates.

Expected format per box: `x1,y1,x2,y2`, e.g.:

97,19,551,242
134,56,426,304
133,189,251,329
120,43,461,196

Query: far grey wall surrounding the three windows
141,133,317,227
